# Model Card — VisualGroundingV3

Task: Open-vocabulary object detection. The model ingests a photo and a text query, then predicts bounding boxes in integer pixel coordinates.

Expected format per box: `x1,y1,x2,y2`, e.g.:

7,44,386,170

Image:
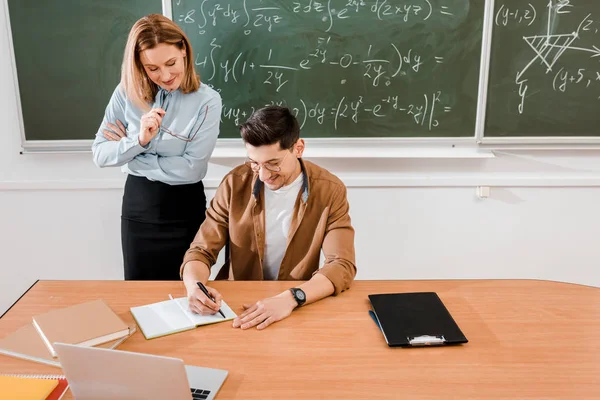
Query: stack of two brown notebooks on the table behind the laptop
0,300,135,367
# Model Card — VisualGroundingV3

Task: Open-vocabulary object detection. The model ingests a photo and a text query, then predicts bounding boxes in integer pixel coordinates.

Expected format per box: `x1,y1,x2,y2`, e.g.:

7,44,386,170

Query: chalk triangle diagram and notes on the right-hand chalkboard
494,0,600,114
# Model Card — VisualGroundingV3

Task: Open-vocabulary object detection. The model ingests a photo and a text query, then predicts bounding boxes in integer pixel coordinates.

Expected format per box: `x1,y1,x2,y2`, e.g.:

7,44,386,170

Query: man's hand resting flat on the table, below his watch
233,291,298,329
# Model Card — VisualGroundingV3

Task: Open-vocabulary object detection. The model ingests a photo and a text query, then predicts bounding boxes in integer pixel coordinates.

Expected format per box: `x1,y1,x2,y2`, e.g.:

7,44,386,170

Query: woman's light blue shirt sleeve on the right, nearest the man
127,92,222,184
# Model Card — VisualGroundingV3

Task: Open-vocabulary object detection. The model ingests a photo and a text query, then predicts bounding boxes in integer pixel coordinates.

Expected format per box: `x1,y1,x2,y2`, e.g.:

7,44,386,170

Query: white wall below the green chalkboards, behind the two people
0,3,600,313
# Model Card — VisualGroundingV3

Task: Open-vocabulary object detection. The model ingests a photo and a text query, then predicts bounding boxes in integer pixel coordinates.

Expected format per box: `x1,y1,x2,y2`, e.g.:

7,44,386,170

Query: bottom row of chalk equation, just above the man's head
218,91,452,131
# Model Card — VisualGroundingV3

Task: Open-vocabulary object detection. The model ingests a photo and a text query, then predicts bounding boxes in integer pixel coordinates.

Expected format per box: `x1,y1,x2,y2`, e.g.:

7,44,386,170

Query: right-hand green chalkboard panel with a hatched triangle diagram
484,0,600,138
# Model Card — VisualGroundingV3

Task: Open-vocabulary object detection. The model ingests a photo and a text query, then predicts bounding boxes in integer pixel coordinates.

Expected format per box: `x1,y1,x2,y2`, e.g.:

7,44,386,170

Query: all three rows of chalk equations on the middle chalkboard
173,0,468,131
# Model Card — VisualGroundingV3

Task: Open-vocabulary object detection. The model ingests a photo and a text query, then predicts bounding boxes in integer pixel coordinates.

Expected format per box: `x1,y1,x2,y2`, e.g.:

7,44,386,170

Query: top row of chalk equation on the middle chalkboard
175,0,454,35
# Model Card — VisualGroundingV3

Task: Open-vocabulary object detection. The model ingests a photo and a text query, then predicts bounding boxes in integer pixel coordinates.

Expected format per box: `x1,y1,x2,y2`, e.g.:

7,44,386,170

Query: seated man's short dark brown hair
240,106,300,150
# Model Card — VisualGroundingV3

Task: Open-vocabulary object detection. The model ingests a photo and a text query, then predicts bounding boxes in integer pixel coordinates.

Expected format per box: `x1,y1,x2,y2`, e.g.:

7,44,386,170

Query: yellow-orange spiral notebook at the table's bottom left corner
0,374,69,400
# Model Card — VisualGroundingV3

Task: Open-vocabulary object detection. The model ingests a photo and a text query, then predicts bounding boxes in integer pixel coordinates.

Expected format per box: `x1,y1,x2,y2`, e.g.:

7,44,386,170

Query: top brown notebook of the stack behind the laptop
33,300,129,357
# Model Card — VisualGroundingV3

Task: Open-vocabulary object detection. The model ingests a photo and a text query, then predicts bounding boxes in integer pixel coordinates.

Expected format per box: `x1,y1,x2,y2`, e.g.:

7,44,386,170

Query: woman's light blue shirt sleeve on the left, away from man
92,85,147,168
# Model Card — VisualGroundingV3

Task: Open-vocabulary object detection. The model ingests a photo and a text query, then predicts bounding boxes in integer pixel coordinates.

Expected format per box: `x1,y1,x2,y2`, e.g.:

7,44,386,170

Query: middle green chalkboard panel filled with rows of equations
172,0,484,138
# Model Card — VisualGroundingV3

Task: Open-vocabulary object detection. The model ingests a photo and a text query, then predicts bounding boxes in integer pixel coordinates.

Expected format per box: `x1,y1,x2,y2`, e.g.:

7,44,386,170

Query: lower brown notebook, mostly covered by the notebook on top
0,324,136,367
